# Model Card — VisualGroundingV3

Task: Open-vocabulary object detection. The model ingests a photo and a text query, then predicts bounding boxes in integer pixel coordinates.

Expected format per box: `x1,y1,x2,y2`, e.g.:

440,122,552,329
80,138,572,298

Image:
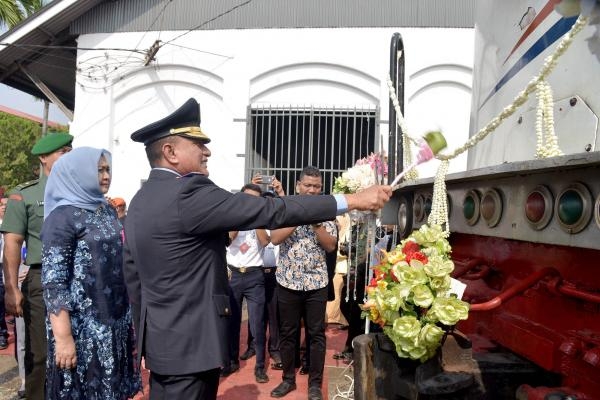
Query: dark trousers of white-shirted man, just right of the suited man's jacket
229,268,265,368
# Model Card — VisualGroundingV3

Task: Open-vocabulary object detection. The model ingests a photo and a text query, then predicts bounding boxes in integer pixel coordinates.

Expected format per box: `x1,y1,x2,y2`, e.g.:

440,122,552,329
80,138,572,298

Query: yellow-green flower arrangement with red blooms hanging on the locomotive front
362,225,469,362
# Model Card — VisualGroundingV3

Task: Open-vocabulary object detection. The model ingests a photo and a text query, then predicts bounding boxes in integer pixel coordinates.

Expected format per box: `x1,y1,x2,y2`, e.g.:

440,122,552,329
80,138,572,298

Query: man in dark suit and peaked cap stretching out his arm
124,99,392,400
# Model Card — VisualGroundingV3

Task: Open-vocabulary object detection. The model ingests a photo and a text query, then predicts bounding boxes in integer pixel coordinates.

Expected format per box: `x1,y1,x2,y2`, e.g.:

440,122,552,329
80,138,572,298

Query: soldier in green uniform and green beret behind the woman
0,133,73,400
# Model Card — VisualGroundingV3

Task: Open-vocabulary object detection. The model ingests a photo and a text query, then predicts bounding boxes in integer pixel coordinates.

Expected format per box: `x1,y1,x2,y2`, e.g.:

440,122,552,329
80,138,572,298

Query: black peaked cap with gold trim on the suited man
131,98,210,146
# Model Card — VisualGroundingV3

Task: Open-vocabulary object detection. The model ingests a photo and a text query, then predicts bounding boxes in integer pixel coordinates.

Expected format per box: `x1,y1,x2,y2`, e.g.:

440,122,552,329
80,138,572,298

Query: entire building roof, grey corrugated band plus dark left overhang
0,0,476,109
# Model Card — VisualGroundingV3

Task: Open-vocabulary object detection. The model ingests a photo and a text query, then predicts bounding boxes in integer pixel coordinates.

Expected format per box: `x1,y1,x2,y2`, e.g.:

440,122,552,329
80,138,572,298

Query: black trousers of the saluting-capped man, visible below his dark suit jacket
150,368,220,400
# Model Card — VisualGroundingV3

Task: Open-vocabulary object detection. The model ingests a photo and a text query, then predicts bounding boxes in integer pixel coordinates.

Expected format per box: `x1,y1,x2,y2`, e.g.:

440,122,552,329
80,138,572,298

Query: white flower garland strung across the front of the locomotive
387,15,589,235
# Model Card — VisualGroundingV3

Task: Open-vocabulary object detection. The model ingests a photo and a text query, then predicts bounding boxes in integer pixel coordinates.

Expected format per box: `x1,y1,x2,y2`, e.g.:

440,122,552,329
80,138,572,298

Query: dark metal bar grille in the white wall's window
245,105,379,194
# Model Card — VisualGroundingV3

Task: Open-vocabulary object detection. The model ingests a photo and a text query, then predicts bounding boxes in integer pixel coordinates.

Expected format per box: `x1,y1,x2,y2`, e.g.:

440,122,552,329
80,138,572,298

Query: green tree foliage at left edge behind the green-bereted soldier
0,112,67,190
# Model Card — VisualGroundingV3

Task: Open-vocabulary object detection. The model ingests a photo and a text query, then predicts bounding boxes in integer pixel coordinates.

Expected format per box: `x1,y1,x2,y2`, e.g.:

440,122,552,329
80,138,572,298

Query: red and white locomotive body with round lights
384,0,600,399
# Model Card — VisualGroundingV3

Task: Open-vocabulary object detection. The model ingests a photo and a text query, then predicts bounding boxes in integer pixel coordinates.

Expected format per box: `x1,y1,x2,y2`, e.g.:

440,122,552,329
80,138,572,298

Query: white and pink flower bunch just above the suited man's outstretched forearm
332,153,387,193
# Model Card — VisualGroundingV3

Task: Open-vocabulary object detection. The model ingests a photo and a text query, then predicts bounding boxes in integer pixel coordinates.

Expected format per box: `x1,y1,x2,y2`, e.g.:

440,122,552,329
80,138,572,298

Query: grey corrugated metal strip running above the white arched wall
71,0,476,34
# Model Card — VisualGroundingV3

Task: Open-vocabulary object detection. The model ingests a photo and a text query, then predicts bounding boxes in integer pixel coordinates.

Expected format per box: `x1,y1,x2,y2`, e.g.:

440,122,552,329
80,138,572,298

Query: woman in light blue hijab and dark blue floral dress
42,147,141,400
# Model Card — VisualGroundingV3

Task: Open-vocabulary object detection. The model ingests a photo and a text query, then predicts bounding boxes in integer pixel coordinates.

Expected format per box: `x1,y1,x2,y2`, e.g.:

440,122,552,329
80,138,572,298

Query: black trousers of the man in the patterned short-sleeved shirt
277,285,327,388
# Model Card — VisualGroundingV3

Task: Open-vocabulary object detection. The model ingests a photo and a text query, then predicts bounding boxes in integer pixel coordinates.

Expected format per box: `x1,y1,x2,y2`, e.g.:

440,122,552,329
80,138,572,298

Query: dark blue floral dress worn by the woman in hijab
42,206,141,400
